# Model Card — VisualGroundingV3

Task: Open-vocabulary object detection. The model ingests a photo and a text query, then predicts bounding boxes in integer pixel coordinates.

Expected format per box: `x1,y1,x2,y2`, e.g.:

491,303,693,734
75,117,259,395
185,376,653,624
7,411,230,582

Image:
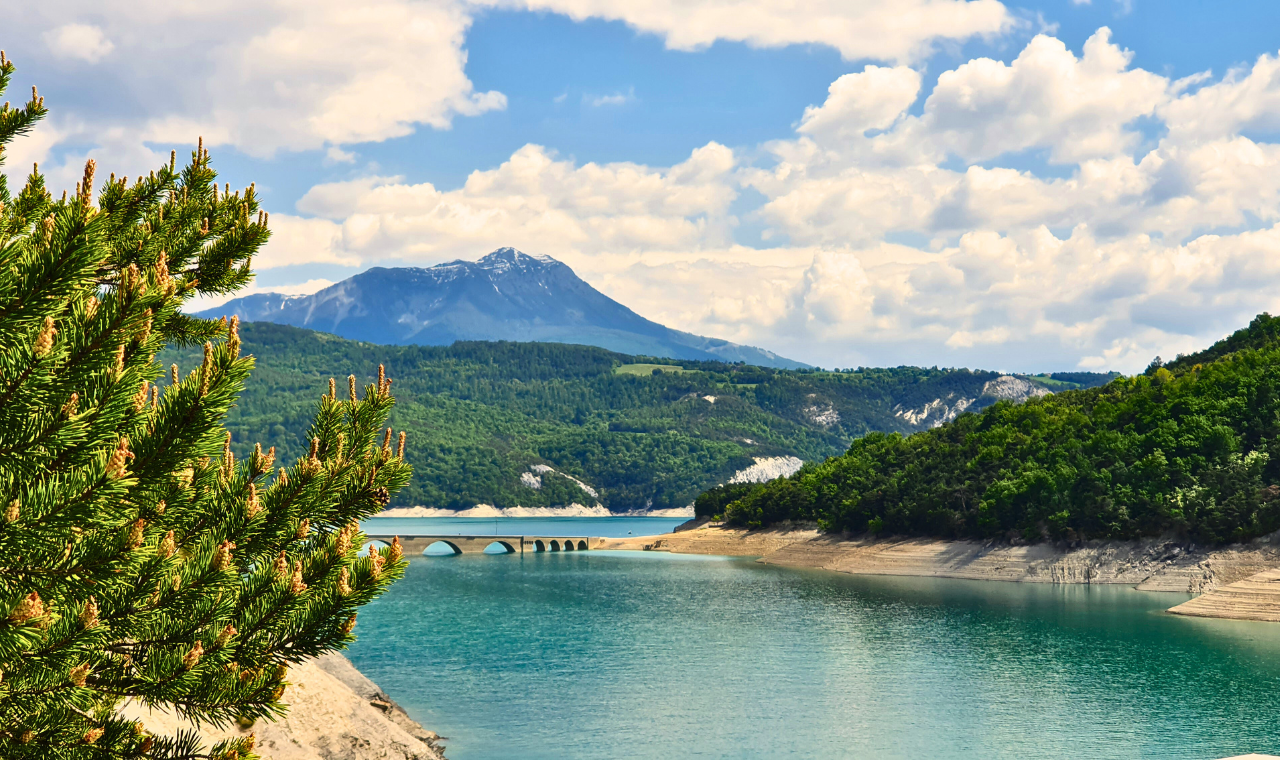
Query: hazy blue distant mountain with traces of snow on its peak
198,248,808,368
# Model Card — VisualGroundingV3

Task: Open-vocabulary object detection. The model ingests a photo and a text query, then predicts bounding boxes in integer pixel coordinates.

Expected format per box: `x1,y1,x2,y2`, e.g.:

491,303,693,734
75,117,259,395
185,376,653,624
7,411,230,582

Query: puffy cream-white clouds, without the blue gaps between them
10,0,1280,371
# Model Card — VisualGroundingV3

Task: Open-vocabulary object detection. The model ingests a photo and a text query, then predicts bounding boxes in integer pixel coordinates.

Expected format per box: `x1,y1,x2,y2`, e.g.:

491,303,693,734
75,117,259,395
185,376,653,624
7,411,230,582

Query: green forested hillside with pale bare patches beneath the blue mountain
160,322,1107,512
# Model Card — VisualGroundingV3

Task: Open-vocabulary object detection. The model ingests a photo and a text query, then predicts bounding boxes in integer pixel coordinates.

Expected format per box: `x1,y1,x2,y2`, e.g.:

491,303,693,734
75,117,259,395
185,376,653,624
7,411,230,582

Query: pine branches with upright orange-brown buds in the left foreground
0,59,410,760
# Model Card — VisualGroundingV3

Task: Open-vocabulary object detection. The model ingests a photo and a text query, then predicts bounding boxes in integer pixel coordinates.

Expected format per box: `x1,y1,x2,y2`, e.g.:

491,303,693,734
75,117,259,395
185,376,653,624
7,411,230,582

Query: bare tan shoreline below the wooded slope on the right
600,521,1280,622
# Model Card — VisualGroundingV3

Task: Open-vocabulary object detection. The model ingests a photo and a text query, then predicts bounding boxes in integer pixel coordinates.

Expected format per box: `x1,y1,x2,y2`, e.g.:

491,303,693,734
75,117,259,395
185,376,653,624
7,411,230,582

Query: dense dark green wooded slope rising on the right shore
696,315,1280,542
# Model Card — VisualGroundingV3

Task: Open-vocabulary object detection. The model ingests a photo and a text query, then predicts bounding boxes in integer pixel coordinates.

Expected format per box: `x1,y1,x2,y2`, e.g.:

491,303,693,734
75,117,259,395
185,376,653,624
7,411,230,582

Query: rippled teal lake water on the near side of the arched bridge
349,551,1280,760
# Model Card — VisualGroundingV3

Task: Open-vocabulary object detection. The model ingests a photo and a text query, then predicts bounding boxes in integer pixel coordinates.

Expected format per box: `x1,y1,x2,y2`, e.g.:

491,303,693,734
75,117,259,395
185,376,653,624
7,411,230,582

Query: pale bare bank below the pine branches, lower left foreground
120,654,444,760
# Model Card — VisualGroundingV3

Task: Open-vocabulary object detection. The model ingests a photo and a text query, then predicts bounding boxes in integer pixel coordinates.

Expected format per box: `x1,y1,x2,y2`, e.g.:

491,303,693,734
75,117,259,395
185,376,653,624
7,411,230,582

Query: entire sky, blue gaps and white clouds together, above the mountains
0,0,1280,371
